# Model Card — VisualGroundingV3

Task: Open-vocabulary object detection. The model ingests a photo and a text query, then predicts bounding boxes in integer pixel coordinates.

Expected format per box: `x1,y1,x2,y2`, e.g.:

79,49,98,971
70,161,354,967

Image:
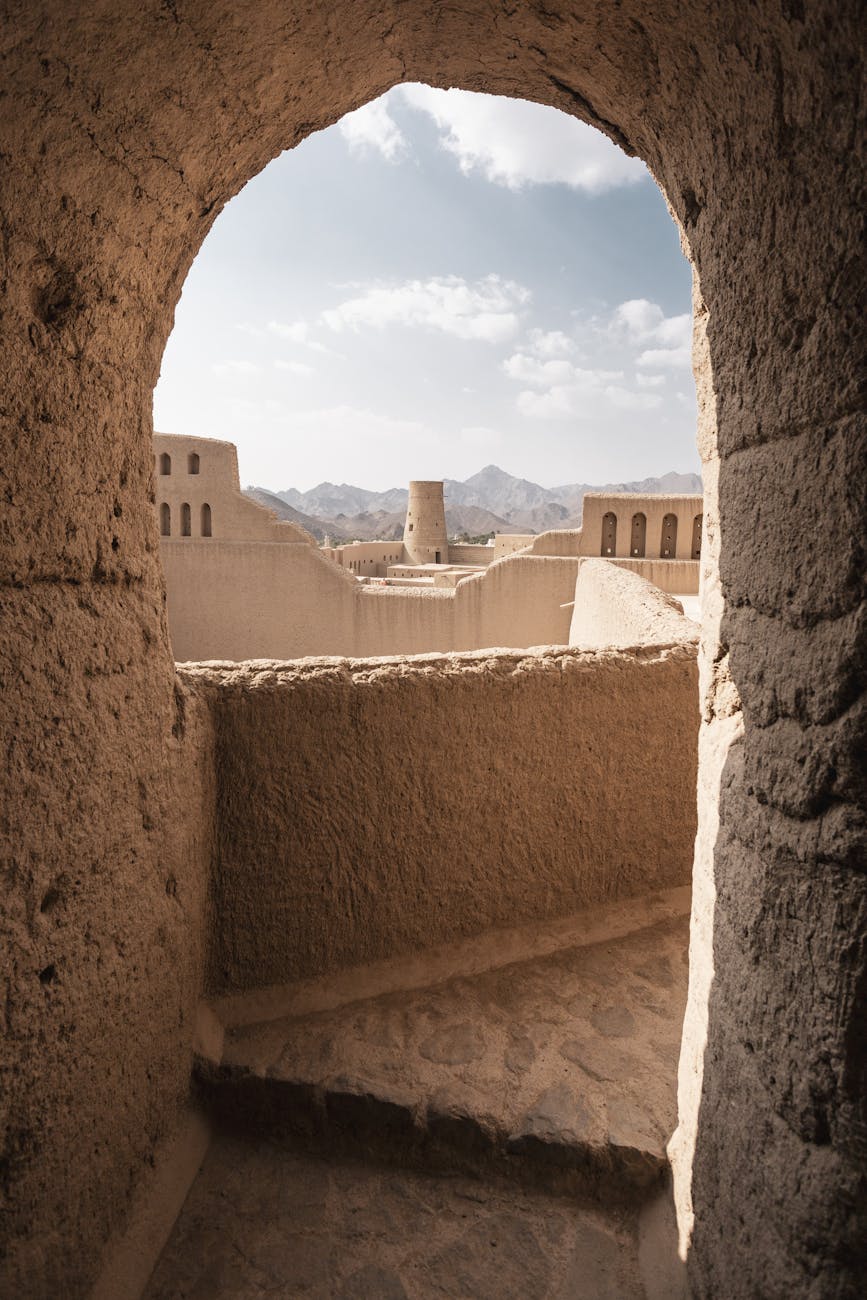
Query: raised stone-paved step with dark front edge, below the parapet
201,917,686,1200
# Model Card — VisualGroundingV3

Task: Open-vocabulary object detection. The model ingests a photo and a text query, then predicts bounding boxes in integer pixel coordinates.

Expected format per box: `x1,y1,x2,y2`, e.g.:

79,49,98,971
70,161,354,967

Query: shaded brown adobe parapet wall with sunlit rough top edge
182,645,698,993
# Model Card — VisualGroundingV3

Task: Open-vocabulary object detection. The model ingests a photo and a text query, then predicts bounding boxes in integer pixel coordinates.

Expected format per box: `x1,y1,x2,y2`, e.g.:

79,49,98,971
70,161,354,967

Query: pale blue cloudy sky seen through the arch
153,86,698,491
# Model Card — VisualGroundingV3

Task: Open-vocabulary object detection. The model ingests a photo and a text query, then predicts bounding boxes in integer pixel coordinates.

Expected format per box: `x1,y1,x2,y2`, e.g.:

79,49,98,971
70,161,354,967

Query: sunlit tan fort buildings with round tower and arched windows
153,434,702,660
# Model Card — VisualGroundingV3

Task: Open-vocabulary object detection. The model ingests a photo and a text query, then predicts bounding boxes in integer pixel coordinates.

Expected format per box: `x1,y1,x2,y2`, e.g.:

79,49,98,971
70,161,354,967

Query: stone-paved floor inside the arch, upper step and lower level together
147,907,688,1300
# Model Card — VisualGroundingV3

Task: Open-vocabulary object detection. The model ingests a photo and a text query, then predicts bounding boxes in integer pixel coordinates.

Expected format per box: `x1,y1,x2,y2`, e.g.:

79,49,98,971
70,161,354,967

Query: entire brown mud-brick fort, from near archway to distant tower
0,0,867,1300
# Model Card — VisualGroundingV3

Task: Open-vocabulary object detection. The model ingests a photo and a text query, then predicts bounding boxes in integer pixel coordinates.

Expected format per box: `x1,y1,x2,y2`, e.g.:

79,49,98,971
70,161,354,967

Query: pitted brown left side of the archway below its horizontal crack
0,611,214,1300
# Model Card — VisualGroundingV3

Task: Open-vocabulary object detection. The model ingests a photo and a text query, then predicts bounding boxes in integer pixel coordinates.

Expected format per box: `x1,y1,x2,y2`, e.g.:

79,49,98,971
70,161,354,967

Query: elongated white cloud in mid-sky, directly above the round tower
322,276,530,343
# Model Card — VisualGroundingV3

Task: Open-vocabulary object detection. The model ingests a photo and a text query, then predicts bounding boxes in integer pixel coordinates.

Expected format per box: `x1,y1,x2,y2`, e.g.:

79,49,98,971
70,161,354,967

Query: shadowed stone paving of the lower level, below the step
144,1136,647,1300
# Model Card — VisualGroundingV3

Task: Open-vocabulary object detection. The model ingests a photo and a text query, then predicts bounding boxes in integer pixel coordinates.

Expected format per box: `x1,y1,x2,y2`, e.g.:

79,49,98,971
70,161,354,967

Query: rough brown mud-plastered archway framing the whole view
0,0,867,1296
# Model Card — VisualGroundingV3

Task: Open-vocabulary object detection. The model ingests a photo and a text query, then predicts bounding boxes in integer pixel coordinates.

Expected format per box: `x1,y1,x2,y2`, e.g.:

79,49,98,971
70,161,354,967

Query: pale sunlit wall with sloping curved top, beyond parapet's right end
569,559,698,650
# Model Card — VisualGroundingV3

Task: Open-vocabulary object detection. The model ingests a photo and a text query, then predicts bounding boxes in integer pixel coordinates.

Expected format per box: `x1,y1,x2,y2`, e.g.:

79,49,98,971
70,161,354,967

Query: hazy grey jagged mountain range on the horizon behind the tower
244,465,702,542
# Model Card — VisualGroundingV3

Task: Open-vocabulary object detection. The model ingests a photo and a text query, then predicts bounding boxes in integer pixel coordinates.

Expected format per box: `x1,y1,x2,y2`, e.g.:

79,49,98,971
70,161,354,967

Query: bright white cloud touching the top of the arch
399,85,647,194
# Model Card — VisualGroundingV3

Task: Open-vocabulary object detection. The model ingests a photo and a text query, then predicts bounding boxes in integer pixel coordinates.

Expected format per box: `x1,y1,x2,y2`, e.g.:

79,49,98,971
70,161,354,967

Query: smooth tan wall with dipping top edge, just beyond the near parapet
162,537,578,662
